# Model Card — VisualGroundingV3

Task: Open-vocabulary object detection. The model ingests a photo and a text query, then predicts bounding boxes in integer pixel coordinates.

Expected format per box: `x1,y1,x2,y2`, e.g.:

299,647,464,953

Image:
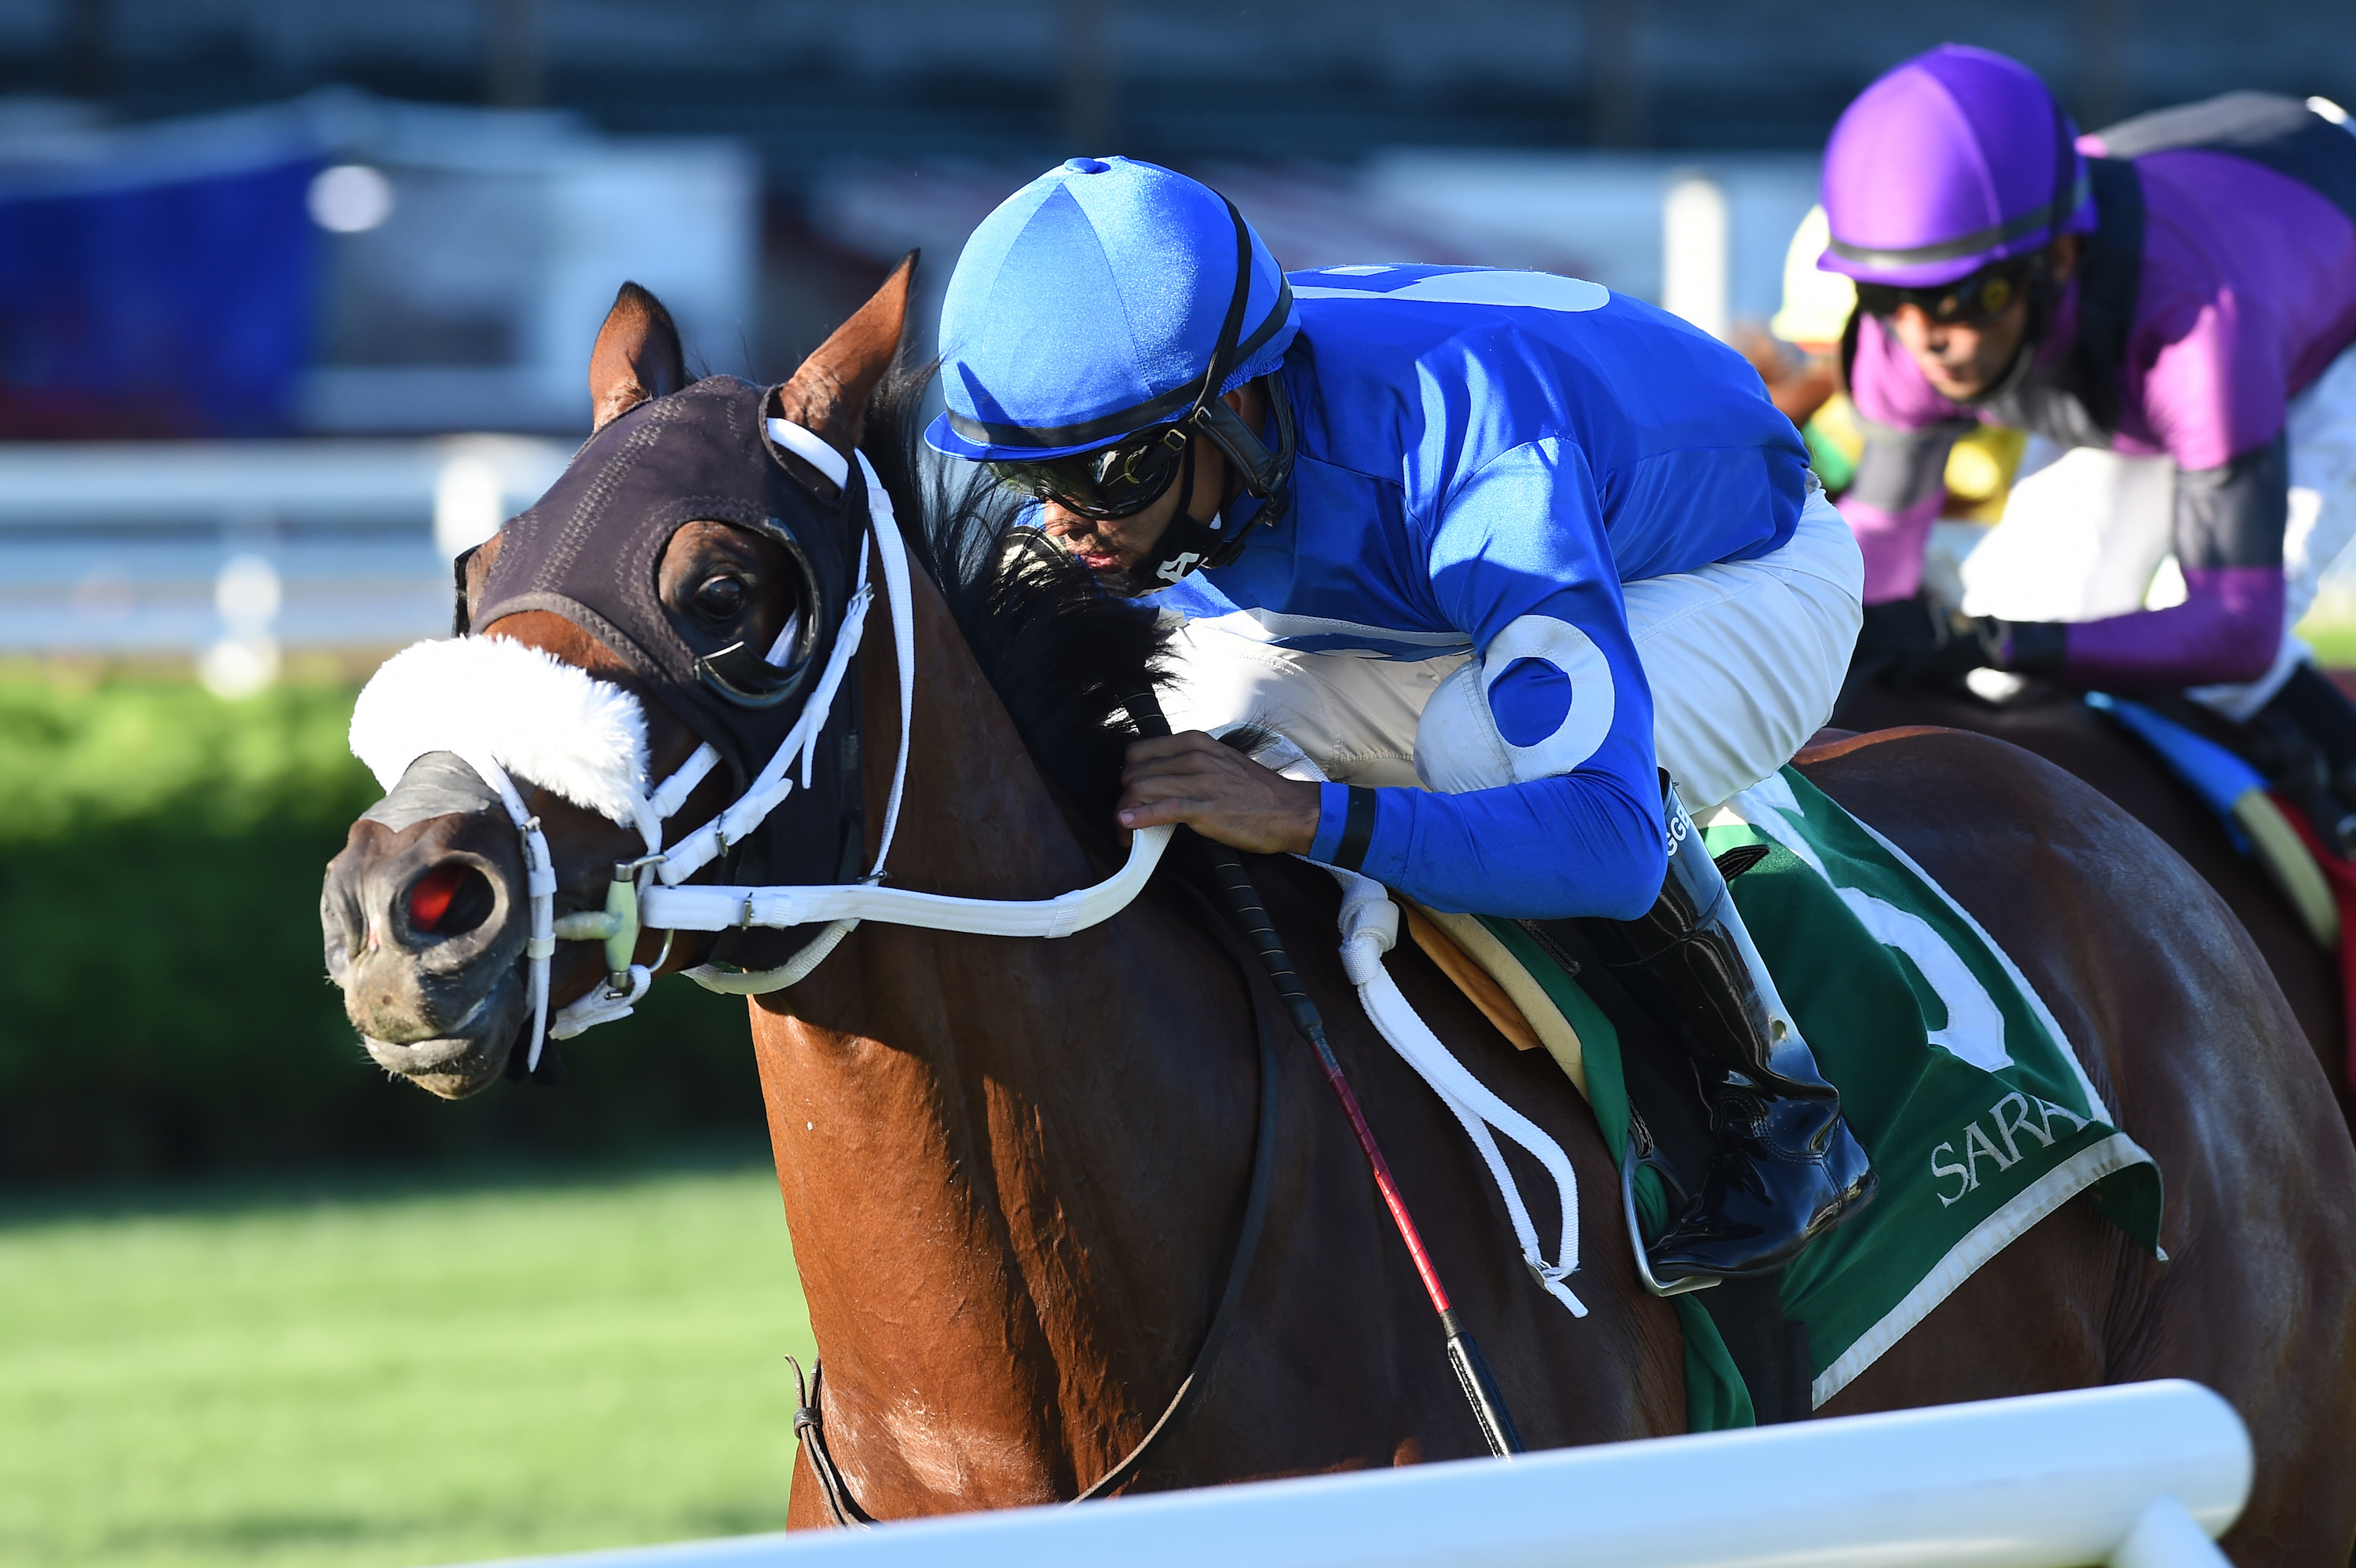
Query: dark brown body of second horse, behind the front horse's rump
1833,685,2356,1125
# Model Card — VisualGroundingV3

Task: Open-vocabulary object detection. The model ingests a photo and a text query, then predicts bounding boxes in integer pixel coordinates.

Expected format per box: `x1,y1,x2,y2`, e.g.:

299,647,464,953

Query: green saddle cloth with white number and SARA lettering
1482,768,2165,1431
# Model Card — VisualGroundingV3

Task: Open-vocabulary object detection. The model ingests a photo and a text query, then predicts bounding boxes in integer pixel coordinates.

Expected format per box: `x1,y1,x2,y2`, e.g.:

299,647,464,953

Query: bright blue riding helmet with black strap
926,158,1301,462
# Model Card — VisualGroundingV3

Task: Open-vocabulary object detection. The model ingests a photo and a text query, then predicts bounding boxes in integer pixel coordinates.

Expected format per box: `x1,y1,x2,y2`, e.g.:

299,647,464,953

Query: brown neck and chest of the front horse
754,557,1256,1516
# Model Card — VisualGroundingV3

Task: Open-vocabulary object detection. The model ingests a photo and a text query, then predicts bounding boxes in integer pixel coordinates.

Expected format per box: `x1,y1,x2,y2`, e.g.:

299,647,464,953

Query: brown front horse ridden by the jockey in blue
323,271,2356,1568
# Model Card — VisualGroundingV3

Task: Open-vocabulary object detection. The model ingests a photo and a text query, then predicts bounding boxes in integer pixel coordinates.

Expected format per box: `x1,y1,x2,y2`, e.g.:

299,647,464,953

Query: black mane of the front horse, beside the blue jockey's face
860,367,1169,821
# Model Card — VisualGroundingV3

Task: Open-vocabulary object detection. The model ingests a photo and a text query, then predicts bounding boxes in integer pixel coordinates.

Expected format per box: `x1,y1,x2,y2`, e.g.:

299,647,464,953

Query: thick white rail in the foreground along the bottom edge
438,1382,2250,1568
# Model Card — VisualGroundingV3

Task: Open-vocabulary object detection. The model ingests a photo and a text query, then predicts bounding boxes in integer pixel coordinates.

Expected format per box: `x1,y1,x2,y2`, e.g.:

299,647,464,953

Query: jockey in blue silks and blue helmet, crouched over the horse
928,158,1873,1290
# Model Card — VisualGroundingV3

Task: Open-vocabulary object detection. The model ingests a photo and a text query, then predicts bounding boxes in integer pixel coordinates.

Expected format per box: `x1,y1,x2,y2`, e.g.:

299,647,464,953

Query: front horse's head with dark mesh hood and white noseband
320,257,914,1099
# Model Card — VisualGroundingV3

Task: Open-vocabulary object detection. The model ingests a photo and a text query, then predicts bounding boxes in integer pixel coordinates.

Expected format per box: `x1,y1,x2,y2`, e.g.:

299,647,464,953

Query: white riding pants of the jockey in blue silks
1162,490,1866,812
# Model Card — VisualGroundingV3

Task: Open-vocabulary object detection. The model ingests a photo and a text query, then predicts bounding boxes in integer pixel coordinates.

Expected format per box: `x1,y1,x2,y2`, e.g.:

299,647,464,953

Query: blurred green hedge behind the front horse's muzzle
0,669,763,1184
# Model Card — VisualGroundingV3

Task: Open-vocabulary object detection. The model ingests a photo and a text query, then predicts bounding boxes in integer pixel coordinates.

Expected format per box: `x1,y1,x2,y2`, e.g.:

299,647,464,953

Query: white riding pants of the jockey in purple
1963,349,2356,723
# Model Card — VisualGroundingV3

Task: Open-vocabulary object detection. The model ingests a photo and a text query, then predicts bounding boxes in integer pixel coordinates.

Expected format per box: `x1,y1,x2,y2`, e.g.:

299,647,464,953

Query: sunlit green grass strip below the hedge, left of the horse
0,1168,810,1568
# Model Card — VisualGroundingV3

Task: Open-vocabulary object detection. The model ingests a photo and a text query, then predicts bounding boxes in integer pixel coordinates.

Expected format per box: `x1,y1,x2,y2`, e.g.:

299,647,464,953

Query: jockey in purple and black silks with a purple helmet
1819,45,2356,845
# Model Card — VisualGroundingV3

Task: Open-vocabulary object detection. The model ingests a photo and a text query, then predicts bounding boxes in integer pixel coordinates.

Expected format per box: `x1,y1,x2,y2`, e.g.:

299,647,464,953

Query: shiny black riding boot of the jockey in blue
1581,775,1875,1292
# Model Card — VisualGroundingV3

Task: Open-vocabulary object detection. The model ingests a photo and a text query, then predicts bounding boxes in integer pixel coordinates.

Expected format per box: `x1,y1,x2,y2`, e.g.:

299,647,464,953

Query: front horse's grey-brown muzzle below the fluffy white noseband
320,754,530,1099
